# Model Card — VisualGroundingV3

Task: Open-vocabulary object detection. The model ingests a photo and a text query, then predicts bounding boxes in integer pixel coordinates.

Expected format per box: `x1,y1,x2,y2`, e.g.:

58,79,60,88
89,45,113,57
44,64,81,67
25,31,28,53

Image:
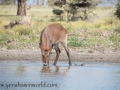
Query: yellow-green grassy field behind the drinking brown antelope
0,6,120,53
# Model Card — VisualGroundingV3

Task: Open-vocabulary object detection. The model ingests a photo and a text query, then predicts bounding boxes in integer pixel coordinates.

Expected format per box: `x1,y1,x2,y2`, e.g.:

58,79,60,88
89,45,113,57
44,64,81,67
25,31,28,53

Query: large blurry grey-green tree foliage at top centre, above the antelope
48,0,101,21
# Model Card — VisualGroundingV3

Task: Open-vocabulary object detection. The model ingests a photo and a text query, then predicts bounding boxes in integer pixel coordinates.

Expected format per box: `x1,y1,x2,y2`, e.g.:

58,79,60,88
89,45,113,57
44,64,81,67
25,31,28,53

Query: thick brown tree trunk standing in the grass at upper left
17,0,26,16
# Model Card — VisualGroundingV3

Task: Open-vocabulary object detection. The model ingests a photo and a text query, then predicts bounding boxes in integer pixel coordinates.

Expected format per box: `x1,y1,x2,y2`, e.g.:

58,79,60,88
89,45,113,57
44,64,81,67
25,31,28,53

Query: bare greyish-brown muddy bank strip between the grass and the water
0,49,120,62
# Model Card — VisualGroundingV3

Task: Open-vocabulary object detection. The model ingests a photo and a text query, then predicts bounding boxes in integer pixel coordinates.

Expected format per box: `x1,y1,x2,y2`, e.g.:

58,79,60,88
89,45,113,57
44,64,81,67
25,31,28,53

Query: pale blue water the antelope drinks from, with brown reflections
0,60,120,90
